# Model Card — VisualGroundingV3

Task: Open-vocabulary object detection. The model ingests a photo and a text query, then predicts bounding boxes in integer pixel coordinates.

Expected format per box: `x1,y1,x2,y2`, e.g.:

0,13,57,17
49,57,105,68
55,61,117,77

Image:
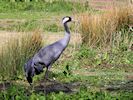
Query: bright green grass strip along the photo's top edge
0,0,84,13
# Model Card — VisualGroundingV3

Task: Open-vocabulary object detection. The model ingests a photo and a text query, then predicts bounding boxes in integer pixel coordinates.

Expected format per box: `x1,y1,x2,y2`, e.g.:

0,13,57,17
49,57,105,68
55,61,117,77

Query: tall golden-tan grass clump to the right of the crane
80,7,132,49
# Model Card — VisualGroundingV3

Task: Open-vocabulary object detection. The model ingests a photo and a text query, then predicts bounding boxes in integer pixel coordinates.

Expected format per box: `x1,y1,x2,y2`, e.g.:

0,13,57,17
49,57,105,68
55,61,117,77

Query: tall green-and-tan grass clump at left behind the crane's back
0,32,42,80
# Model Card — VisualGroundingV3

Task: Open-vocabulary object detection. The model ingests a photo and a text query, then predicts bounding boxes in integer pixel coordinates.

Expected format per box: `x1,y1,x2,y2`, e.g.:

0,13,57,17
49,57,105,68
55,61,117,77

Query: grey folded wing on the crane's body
33,41,64,66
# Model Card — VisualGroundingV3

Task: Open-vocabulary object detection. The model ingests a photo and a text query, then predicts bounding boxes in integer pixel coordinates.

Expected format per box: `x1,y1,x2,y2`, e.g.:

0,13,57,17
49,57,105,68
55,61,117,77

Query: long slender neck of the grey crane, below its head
62,23,70,47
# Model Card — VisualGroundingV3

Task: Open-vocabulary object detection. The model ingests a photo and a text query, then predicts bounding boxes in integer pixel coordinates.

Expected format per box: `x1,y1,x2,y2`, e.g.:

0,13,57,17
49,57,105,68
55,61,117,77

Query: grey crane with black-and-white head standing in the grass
24,16,72,84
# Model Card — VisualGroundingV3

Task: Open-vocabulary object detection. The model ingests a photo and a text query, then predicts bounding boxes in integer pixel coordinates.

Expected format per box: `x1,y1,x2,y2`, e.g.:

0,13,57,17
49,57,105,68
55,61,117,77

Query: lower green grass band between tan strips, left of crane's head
1,20,62,32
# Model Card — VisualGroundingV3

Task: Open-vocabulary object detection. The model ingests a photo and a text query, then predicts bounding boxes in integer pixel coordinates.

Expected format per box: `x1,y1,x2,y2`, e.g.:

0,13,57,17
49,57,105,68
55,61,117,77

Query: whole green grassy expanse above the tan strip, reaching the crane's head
0,0,93,32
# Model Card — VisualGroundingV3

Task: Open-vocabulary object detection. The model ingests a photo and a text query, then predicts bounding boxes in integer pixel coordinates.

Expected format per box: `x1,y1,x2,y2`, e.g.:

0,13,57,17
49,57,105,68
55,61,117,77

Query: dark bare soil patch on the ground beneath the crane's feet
34,81,81,94
